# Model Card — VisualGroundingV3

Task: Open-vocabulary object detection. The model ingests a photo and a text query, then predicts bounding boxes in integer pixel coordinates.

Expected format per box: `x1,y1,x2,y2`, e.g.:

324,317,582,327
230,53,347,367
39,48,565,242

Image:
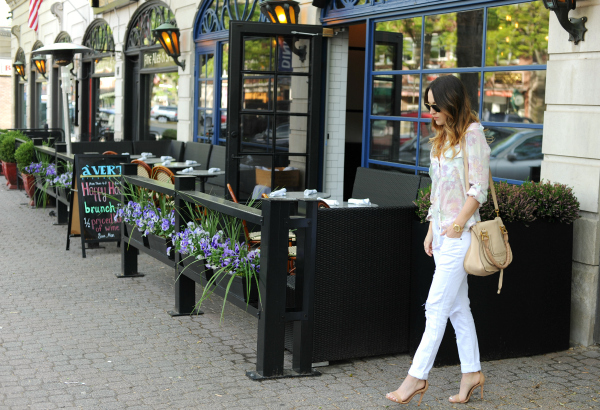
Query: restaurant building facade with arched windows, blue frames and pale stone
7,0,600,345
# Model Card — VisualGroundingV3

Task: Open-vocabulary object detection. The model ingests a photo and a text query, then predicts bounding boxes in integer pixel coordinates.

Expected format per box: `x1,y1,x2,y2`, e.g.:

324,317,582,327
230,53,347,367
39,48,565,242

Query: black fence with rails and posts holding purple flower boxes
121,164,319,380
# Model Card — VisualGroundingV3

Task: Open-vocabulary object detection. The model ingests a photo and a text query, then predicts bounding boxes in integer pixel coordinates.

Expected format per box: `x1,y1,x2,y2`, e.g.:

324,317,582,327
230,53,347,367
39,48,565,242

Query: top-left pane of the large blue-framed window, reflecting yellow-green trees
373,17,423,71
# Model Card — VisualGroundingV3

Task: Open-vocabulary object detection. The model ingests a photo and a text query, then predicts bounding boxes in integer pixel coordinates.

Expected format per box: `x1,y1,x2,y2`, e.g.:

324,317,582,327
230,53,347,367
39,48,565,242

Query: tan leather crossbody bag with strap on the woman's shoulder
461,139,512,293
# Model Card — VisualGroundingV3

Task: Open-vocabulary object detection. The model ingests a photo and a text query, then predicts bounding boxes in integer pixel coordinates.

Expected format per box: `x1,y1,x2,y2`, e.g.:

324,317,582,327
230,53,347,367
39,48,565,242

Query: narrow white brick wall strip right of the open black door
323,31,348,202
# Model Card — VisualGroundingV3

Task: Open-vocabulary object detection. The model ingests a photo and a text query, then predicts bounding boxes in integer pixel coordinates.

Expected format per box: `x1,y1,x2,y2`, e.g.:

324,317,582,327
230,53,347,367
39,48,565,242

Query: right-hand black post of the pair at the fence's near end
292,201,318,373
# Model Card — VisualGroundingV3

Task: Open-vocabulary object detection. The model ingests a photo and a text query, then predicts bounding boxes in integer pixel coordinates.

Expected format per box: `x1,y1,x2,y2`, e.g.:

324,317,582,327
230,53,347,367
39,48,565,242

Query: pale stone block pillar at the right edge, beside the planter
532,0,600,346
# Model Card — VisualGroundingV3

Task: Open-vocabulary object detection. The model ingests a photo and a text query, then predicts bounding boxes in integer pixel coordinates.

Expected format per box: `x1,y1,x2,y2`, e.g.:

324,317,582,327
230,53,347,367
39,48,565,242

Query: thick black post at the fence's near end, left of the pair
252,200,292,378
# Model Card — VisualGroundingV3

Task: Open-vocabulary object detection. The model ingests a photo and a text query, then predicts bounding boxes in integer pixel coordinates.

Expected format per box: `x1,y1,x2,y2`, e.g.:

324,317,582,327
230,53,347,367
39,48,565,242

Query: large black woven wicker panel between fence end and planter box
286,206,415,363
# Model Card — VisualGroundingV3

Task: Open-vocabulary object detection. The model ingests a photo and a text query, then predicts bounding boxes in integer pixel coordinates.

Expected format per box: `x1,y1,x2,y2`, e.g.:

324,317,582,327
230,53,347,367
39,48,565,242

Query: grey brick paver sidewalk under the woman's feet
0,184,600,410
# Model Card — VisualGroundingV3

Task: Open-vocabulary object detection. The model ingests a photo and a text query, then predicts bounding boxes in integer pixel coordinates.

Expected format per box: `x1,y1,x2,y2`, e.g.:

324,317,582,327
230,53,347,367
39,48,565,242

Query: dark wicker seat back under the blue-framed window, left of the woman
352,168,421,206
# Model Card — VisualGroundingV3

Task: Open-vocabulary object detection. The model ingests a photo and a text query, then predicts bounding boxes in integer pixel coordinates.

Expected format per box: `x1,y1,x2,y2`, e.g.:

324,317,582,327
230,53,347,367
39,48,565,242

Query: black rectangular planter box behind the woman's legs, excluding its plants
410,220,573,366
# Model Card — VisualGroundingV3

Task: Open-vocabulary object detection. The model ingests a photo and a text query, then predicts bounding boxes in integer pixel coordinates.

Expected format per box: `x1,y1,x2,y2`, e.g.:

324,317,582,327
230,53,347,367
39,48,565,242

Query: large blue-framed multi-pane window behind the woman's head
364,1,549,183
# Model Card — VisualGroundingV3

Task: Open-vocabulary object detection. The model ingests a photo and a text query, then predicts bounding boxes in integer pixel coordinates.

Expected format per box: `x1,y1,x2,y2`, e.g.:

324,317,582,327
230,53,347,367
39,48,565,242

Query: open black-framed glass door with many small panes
227,22,323,199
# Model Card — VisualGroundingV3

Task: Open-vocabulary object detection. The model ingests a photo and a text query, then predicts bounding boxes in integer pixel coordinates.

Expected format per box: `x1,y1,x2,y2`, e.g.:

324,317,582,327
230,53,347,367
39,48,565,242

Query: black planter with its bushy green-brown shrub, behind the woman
410,182,579,365
